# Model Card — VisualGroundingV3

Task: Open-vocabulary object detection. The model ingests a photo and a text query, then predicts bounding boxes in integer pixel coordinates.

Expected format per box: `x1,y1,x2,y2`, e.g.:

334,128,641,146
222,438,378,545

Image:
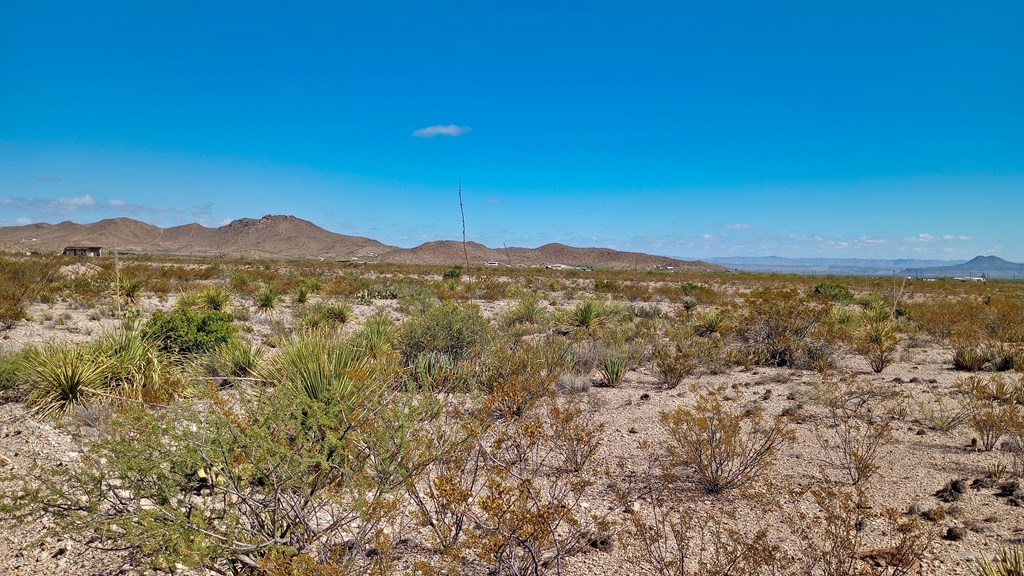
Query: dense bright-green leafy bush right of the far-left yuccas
141,307,234,355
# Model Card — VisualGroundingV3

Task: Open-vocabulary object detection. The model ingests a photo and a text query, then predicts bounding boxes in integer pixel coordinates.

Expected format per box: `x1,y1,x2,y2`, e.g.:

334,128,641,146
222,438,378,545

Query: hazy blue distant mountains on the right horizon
708,256,1024,279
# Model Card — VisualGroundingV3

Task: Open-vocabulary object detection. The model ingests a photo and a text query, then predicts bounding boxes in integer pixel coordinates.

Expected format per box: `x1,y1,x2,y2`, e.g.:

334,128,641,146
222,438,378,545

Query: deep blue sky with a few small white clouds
0,0,1024,261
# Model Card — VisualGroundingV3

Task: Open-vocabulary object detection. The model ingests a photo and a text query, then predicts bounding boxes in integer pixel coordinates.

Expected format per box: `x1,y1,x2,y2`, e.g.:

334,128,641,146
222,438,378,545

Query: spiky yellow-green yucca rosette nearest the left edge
18,343,106,416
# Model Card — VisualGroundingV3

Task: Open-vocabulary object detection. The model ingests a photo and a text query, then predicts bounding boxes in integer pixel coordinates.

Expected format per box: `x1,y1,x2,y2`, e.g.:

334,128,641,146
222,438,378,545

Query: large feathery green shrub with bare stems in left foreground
0,368,437,574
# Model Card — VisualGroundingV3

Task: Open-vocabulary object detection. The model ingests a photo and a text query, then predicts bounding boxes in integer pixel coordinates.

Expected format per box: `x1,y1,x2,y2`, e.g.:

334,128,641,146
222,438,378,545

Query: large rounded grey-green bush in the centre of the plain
398,302,488,362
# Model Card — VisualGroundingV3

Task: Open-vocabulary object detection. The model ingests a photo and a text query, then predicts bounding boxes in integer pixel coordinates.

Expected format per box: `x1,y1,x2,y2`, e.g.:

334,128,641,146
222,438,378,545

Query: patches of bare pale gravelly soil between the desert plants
0,293,1024,576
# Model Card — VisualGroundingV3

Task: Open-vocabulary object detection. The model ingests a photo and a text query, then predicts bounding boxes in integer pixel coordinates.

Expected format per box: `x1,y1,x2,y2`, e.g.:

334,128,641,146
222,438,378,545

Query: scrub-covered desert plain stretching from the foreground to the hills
0,256,1024,576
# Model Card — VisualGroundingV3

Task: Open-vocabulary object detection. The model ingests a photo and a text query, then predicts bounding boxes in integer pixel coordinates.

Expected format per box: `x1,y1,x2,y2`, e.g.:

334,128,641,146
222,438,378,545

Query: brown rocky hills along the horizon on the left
0,215,723,271
